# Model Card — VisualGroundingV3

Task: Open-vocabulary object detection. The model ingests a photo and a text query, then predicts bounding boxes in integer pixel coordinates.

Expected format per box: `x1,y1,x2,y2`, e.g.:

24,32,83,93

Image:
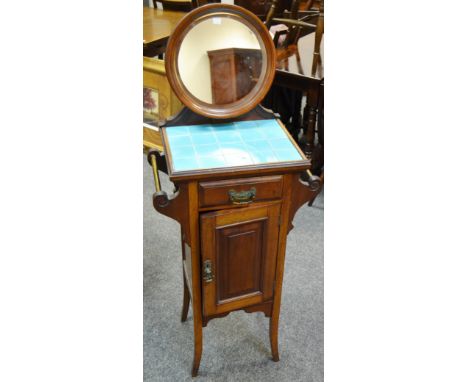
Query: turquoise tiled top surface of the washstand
166,119,303,172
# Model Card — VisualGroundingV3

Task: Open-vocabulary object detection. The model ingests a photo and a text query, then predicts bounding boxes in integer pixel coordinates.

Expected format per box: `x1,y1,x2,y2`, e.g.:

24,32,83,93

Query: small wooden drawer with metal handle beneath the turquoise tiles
198,175,283,207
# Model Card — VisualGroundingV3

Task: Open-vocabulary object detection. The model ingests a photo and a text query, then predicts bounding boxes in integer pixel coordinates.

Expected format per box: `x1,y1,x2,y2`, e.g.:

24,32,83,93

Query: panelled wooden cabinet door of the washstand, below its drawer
201,203,281,316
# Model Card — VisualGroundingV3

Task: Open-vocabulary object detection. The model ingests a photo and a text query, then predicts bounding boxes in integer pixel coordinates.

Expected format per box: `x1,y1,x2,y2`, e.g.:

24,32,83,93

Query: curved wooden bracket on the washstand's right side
288,172,323,232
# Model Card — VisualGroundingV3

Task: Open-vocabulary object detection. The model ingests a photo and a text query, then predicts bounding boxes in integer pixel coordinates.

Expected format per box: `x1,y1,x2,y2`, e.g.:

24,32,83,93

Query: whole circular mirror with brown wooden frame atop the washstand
166,4,275,118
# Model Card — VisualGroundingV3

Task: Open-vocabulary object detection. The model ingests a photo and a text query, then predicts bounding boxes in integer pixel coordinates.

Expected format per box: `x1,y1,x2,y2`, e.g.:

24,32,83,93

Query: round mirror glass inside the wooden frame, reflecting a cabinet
177,14,266,105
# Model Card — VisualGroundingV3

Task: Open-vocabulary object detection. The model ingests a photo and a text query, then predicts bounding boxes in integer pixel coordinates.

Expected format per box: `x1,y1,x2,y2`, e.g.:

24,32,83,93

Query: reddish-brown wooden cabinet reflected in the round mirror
207,48,262,105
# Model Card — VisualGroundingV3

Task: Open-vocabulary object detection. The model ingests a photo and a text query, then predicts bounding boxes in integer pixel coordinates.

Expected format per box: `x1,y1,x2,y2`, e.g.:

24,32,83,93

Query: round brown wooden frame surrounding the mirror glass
165,4,276,119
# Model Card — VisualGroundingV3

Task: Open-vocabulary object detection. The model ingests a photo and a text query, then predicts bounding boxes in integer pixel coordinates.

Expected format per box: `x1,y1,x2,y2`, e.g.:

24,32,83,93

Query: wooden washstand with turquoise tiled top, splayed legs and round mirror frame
148,4,321,377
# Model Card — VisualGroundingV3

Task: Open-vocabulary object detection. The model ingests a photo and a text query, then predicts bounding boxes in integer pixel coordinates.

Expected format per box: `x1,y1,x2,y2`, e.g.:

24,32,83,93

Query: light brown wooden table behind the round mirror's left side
143,7,186,57
